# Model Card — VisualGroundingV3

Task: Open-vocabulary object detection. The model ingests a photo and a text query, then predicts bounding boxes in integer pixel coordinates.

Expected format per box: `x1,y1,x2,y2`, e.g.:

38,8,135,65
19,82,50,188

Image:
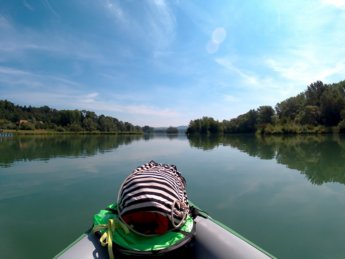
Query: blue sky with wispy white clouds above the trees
0,0,345,127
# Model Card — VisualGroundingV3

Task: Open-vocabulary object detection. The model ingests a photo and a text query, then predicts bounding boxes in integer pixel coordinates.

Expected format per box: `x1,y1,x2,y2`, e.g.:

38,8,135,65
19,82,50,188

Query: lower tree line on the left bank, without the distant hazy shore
0,100,143,133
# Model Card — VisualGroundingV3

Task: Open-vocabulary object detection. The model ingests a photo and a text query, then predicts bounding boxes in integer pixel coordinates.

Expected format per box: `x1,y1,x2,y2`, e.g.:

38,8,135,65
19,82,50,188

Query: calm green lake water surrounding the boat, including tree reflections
0,136,345,258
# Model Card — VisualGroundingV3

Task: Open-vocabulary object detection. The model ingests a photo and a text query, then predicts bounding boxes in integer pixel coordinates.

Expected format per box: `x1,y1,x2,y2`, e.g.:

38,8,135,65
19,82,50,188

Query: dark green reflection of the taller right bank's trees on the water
189,135,345,185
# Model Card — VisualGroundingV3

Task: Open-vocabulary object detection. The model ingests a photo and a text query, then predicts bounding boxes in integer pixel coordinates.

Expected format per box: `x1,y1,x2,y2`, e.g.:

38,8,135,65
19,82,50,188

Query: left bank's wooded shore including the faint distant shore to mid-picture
0,100,186,135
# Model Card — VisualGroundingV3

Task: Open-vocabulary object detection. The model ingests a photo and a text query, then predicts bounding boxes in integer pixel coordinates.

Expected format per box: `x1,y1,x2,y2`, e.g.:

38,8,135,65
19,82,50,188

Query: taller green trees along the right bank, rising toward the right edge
187,81,345,135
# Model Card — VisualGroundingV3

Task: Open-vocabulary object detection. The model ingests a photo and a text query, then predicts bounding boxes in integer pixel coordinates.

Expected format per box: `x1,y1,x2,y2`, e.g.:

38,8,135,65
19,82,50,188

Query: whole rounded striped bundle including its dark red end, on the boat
118,161,189,235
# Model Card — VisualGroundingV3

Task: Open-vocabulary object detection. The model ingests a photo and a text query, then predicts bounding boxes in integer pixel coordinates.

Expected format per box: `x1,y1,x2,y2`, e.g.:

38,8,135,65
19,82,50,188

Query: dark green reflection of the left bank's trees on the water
0,135,143,167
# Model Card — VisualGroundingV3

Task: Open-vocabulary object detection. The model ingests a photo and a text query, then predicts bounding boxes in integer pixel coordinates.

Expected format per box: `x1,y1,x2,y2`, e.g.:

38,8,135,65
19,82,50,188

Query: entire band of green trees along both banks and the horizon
0,80,345,136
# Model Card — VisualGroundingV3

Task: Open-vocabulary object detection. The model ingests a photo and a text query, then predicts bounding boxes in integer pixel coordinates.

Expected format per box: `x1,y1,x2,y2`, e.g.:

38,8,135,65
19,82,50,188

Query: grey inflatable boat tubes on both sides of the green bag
55,204,275,259
